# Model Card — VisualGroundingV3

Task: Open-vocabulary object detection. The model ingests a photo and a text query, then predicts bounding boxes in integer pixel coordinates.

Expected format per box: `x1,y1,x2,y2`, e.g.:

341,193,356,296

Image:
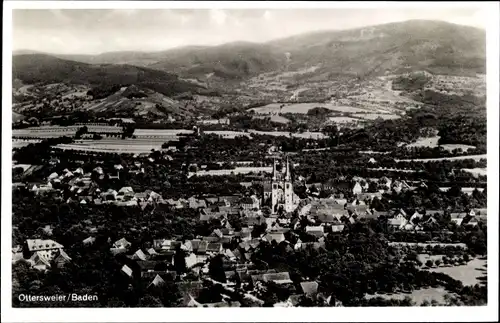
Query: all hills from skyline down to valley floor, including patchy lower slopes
13,20,486,120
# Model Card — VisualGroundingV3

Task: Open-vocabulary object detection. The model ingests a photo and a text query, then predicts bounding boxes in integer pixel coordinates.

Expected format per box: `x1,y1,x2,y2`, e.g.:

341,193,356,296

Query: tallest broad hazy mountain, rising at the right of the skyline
270,20,486,77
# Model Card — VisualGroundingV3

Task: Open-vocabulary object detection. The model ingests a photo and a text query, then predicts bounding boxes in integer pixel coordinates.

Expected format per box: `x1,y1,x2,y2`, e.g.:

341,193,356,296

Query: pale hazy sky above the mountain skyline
13,7,486,54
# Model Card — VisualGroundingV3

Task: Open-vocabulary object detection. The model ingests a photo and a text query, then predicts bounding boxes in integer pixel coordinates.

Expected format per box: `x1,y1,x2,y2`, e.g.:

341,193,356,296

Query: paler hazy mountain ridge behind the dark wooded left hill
14,20,486,80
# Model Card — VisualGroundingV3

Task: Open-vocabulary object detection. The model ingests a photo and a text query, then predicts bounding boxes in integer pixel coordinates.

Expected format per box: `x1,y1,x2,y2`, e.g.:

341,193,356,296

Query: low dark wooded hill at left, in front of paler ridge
12,54,204,96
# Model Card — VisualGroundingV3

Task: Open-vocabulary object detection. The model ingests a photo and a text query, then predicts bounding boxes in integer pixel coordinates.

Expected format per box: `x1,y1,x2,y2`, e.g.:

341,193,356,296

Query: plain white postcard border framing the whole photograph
1,1,500,322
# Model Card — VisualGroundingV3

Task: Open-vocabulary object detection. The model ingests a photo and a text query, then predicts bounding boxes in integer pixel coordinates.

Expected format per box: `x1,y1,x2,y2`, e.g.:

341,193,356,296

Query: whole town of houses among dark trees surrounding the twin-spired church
13,117,487,307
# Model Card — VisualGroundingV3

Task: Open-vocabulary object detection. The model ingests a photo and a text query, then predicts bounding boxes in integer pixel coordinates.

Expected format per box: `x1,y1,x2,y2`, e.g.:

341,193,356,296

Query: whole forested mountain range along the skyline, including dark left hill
13,20,486,121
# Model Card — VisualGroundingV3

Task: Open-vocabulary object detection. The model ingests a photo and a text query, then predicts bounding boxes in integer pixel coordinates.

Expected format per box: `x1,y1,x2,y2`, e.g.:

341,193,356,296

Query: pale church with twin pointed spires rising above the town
264,157,298,215
